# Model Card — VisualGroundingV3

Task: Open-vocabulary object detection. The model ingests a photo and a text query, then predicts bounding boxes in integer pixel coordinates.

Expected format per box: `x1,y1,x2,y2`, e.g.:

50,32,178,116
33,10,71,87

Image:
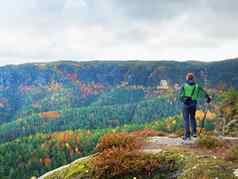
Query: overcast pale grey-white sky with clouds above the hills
0,0,238,65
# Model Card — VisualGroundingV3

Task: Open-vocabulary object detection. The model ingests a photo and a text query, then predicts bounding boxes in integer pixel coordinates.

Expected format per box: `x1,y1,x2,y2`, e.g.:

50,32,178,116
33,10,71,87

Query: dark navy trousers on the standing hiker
183,103,197,139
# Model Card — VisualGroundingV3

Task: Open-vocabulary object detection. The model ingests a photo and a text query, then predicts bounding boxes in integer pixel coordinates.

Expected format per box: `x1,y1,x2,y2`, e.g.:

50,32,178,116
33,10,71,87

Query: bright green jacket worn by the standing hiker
180,83,208,101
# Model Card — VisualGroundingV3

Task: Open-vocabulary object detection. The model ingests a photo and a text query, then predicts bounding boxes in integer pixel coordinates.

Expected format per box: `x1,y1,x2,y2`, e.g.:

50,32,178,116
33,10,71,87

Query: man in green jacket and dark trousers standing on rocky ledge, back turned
180,73,211,141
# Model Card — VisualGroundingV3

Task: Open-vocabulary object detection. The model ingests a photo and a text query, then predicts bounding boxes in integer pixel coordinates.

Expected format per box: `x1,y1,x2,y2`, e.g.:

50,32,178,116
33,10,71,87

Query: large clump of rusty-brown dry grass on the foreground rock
90,130,178,179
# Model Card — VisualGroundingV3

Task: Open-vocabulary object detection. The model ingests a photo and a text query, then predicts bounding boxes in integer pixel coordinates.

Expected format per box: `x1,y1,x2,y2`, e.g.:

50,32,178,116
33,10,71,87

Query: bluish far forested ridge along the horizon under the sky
0,59,238,123
